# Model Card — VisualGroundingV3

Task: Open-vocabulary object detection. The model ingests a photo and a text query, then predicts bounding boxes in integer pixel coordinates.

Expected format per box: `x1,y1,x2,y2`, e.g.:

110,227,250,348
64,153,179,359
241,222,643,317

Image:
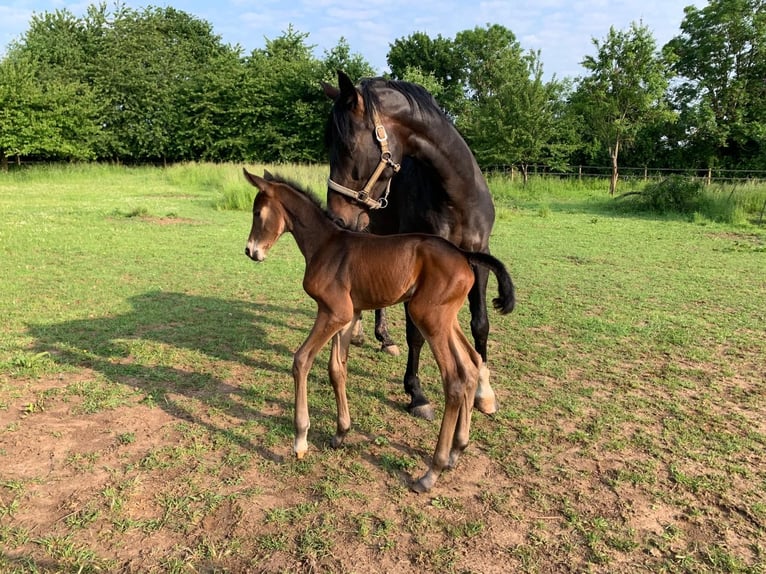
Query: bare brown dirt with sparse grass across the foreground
0,348,766,574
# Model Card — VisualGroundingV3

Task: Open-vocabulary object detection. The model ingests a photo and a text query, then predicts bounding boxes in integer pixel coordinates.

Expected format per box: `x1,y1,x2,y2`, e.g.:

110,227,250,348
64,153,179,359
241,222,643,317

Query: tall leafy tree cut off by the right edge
664,0,766,169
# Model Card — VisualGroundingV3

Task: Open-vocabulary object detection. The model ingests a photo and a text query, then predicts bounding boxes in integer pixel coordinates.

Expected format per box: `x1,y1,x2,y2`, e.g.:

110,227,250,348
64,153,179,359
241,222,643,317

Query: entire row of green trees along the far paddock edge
0,0,766,191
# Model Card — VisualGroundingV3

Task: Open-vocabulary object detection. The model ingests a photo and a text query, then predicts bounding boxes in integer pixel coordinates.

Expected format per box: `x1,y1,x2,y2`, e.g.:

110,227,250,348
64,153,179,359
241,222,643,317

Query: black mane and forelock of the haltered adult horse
325,78,448,153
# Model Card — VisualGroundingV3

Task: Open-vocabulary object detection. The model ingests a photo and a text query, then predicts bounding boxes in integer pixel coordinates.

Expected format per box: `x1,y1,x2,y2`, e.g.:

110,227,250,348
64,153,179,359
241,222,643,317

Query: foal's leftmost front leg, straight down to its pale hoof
293,309,348,459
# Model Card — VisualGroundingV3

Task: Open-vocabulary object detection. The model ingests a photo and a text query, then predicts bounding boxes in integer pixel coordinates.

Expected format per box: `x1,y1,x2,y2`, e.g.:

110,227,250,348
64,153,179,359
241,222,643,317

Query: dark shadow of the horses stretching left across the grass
27,290,402,468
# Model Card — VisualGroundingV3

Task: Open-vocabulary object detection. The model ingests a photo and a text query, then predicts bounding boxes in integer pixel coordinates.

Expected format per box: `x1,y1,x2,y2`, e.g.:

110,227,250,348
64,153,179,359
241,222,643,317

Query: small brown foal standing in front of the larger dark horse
245,170,514,492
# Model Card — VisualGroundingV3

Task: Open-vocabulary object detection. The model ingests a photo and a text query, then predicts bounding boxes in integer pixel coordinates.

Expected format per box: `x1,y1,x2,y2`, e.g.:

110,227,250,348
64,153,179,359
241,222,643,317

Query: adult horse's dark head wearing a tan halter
323,71,403,230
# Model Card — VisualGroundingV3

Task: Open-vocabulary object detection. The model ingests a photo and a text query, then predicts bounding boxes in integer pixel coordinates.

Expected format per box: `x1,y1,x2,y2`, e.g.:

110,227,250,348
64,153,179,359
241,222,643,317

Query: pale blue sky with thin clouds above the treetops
0,0,707,79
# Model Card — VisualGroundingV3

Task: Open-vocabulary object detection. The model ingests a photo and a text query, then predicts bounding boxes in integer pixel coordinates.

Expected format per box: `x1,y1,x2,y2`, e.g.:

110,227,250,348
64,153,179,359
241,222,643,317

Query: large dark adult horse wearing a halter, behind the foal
323,71,497,420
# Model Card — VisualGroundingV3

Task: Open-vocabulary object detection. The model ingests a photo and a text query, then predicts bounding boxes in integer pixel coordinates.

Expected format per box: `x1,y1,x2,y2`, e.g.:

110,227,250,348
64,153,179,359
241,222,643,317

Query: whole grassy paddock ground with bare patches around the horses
0,165,766,573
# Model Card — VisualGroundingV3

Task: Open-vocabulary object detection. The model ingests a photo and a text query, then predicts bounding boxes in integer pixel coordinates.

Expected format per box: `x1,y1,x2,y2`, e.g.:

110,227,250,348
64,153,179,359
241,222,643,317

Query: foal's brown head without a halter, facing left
242,168,287,262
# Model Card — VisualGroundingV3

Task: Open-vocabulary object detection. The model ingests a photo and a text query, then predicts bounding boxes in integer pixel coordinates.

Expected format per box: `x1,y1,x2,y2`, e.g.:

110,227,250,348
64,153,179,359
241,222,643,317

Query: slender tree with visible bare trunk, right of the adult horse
573,22,668,194
